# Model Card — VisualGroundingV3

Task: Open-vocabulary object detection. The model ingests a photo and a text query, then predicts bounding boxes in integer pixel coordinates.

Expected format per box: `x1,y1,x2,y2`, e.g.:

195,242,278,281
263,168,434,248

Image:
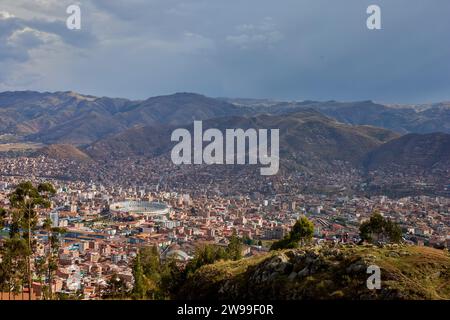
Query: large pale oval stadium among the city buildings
109,201,169,216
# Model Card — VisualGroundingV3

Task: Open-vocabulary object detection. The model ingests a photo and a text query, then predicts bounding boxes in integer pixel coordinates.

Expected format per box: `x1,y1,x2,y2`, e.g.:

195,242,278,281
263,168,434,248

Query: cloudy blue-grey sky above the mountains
0,0,450,103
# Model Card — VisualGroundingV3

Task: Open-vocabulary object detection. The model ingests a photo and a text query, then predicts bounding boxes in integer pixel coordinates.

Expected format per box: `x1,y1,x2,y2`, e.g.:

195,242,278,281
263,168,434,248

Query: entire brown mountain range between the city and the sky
0,91,450,181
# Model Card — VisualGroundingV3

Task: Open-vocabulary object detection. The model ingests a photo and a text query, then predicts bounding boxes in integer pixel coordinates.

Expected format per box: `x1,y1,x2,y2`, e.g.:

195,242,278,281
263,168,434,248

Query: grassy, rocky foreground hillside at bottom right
177,245,450,300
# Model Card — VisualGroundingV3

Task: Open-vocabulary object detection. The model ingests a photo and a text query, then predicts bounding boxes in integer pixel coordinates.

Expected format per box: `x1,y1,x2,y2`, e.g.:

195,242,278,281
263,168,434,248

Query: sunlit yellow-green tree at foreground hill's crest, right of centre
270,217,314,250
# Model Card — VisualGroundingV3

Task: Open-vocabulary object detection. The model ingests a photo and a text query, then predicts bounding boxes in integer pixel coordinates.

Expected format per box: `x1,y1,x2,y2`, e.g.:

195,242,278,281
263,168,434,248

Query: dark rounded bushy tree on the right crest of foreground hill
359,212,402,243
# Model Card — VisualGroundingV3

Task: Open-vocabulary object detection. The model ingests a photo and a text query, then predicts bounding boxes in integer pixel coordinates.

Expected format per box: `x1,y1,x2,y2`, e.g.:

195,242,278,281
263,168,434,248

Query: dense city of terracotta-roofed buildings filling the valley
0,156,450,299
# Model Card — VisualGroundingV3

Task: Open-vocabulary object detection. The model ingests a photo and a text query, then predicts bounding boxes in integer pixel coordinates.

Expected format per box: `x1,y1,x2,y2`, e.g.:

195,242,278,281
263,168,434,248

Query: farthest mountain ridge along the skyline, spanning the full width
0,91,450,146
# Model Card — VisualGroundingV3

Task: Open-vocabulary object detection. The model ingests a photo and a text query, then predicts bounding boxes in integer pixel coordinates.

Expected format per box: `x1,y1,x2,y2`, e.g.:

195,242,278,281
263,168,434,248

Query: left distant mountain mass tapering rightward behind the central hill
0,91,246,145
